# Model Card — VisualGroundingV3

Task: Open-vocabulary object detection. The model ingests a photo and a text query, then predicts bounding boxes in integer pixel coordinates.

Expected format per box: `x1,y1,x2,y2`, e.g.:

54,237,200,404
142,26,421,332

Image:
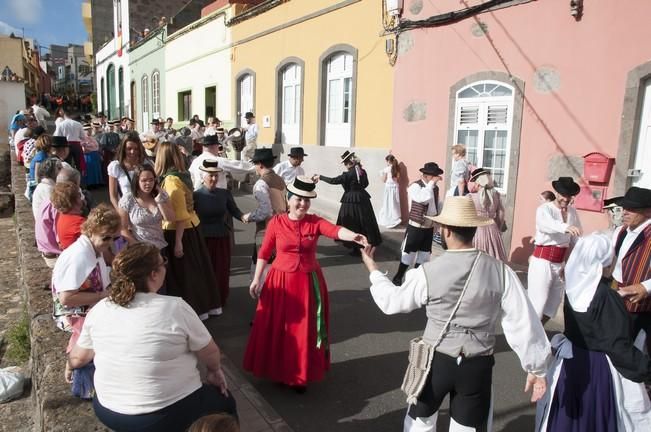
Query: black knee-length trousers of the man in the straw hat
409,352,495,431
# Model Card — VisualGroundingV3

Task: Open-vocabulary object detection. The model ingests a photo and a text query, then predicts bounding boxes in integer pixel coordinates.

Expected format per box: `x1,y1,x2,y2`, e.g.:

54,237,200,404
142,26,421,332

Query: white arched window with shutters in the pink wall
454,81,513,193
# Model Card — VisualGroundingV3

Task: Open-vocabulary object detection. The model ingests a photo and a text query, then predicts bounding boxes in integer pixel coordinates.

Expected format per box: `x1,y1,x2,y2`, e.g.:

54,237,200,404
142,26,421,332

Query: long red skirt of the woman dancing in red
244,267,330,385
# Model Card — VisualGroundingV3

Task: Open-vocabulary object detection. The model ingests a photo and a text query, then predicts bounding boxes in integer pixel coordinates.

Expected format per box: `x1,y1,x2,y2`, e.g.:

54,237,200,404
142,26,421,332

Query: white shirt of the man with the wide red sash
534,202,581,247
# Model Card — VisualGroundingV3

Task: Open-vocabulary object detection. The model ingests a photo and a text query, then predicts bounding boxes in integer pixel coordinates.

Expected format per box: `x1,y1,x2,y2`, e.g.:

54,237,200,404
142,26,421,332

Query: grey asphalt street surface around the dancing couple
206,192,559,432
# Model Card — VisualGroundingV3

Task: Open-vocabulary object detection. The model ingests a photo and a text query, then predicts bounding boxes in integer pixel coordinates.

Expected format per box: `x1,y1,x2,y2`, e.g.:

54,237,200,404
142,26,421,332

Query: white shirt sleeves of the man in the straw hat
369,251,551,376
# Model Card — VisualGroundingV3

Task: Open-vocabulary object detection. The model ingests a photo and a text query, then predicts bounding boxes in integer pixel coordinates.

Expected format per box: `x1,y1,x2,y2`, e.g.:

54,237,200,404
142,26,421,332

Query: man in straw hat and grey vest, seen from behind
362,197,551,432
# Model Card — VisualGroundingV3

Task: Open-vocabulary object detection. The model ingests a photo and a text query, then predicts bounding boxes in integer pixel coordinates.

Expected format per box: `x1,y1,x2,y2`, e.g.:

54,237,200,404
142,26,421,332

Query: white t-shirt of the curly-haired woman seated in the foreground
77,293,212,415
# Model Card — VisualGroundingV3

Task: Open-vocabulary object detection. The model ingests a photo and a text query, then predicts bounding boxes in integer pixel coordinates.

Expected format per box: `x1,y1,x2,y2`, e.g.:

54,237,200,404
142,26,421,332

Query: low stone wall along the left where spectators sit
11,159,108,432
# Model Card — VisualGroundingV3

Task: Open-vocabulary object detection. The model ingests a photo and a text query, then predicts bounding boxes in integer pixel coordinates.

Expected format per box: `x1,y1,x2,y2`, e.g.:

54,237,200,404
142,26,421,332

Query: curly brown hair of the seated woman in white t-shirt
109,242,160,306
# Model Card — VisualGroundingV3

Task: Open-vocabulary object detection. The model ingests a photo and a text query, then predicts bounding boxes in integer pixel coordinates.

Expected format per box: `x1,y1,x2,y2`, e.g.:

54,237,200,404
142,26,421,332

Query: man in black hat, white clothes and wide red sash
527,177,581,324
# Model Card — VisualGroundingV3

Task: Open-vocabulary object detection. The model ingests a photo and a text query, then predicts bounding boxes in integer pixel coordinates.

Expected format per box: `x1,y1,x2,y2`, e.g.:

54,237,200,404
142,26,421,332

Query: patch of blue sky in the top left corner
0,0,88,47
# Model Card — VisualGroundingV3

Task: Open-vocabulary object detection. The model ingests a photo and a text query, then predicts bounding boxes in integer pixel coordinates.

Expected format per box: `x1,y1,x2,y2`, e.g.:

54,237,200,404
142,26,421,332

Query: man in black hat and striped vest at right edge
611,186,651,353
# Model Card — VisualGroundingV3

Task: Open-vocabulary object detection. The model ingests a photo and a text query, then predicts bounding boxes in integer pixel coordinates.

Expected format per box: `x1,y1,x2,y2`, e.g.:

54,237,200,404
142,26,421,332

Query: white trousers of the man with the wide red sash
527,256,565,319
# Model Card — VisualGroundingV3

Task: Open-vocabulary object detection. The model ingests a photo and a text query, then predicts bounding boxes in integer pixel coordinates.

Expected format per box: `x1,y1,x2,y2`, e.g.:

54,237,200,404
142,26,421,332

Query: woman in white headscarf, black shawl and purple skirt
535,233,651,432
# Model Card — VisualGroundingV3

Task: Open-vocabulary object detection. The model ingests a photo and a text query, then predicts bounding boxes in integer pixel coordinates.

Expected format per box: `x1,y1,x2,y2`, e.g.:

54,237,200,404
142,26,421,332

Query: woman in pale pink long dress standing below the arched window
470,168,506,261
